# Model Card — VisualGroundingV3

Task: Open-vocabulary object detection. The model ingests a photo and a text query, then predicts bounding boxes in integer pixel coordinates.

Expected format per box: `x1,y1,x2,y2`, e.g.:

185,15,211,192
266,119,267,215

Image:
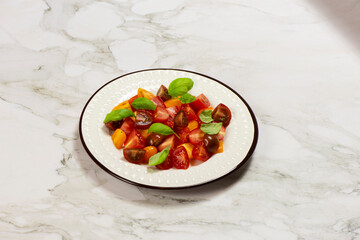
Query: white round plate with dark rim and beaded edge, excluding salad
79,69,258,189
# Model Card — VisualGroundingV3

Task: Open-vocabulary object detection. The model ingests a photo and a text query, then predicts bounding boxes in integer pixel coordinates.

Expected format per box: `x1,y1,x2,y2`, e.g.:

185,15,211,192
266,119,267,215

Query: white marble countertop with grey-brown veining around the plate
0,0,360,240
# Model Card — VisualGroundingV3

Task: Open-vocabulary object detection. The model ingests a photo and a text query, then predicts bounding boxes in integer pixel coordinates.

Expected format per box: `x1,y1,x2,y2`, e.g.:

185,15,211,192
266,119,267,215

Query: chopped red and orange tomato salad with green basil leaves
103,78,231,170
